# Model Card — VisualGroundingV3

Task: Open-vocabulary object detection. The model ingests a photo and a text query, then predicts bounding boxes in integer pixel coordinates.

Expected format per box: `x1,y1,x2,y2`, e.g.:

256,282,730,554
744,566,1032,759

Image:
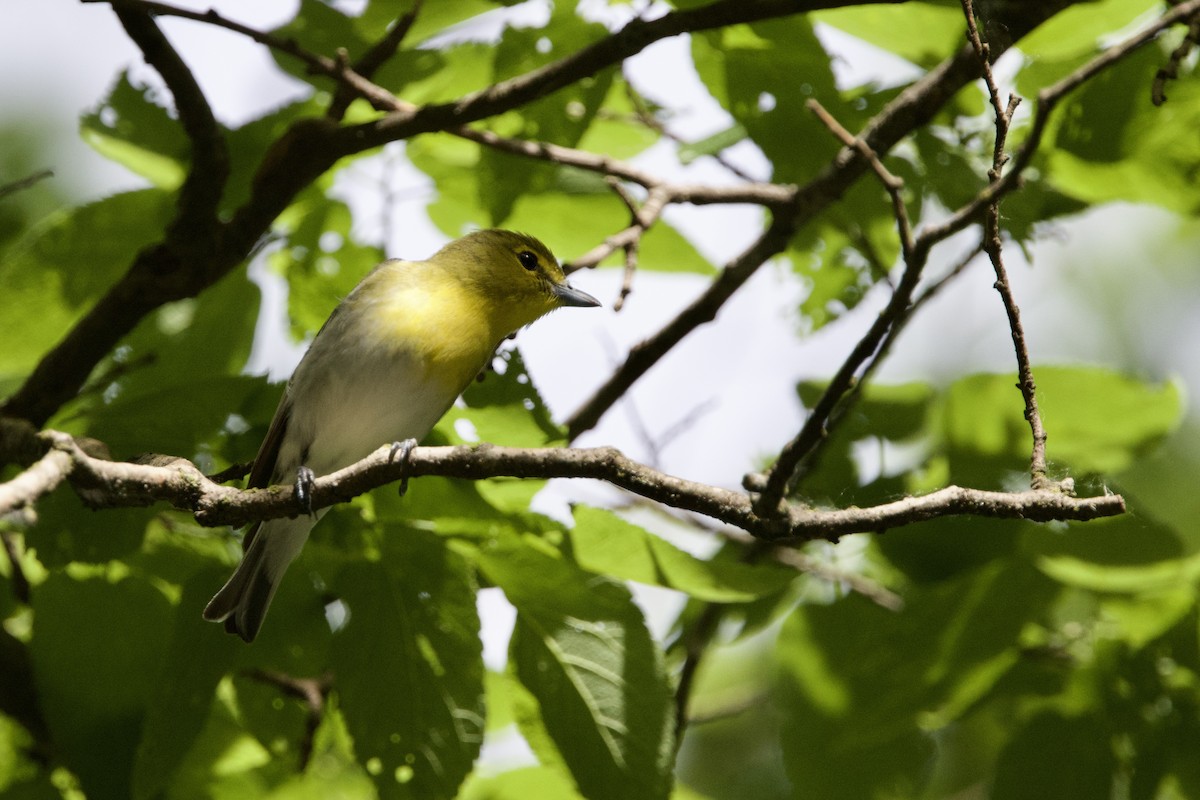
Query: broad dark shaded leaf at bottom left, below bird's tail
29,567,172,798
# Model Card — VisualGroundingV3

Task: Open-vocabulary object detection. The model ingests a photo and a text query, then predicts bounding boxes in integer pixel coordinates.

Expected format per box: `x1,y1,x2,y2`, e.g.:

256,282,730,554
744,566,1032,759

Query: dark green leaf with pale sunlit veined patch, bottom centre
475,537,674,800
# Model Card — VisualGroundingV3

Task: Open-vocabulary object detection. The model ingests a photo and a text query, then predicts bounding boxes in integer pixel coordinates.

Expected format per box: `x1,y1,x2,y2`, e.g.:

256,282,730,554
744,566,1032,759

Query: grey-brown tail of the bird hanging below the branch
204,517,317,642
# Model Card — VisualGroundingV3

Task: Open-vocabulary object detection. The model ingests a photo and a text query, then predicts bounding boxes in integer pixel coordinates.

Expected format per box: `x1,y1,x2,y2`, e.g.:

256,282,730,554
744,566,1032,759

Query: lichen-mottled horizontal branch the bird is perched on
0,420,1124,542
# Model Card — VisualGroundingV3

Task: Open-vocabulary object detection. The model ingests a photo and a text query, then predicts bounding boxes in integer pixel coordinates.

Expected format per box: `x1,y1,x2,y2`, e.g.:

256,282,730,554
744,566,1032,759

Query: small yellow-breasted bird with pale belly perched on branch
204,229,600,643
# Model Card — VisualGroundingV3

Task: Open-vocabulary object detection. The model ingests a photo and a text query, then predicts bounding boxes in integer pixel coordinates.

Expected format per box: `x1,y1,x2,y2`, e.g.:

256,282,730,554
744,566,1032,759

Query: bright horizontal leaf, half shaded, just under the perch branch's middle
570,506,796,603
